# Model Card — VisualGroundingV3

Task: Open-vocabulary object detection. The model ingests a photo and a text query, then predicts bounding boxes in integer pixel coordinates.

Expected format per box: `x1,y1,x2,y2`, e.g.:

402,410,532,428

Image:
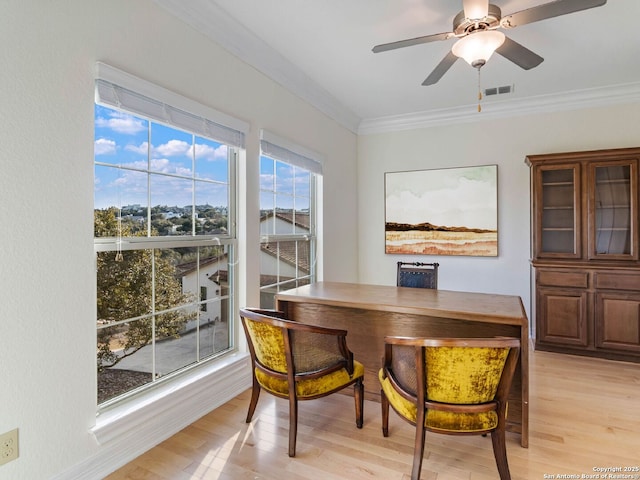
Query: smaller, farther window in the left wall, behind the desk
260,131,322,308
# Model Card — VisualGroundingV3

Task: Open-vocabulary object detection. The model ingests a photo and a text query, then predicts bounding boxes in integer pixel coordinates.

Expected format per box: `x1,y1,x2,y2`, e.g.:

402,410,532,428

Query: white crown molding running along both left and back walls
154,0,640,135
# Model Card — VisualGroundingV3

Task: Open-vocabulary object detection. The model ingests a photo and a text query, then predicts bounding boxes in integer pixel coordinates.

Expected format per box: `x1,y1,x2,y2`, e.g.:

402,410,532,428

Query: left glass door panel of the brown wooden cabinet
538,165,580,257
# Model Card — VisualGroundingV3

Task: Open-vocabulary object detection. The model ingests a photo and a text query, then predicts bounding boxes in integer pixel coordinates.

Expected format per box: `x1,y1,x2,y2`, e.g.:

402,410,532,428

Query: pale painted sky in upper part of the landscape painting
385,165,498,230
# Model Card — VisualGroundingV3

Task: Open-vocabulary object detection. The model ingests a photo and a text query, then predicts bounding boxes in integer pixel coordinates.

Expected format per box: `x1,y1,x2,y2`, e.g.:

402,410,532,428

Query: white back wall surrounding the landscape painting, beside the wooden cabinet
358,103,640,324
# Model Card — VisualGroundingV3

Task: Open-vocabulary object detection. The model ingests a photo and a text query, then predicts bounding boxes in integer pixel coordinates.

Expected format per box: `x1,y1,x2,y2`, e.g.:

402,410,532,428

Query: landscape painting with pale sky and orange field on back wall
385,165,498,257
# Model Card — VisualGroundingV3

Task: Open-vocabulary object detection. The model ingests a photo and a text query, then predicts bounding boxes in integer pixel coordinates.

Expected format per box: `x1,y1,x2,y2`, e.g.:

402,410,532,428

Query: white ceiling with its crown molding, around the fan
155,0,640,131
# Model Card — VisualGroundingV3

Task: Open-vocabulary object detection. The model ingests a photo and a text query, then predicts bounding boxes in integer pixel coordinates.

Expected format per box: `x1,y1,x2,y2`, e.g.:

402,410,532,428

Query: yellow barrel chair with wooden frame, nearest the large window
240,308,364,457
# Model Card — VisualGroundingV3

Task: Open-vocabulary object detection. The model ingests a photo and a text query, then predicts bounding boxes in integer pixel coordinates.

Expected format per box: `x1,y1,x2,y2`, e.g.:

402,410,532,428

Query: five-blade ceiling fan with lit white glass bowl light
373,0,607,85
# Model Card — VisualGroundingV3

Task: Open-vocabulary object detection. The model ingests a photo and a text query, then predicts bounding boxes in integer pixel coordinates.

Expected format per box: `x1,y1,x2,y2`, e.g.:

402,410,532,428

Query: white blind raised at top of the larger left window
96,63,249,148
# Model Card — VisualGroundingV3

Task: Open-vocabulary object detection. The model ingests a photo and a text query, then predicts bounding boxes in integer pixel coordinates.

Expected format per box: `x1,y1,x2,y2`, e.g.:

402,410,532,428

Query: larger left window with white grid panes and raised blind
94,62,244,407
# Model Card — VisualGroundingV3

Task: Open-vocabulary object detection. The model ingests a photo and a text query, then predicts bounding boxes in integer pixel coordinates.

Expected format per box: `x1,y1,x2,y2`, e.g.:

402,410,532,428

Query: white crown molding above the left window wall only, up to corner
154,0,361,133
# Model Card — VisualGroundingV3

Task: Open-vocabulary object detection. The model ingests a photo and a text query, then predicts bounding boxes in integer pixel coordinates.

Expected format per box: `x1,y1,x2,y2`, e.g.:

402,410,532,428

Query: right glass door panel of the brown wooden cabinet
589,161,637,259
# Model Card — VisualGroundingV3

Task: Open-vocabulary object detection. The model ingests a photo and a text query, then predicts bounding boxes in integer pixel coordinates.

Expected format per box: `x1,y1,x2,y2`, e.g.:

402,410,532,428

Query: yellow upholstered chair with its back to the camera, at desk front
379,337,520,480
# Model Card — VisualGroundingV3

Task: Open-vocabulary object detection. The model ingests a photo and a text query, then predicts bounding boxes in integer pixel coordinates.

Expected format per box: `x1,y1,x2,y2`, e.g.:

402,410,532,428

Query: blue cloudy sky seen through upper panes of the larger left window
94,105,228,208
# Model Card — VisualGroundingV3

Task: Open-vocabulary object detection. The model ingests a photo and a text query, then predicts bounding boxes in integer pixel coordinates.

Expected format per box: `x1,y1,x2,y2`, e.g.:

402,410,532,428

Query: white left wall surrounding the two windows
0,0,357,480
